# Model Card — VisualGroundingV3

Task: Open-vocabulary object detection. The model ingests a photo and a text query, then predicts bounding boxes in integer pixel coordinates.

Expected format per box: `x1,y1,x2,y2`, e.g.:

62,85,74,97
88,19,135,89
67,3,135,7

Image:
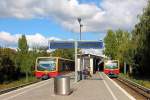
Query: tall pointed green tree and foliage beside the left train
17,35,48,81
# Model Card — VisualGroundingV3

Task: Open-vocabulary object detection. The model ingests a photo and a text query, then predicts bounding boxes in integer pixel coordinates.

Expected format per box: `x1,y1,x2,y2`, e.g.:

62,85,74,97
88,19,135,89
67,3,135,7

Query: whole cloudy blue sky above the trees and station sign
0,0,147,47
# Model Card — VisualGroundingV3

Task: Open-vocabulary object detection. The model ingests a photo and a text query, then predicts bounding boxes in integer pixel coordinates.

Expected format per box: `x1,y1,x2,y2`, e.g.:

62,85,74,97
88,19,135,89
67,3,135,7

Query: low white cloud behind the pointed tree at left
0,31,60,47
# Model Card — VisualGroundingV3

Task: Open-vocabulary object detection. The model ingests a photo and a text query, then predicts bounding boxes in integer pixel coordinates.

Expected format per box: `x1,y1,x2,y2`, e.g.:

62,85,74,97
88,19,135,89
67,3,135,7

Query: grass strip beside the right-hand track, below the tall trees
119,73,150,88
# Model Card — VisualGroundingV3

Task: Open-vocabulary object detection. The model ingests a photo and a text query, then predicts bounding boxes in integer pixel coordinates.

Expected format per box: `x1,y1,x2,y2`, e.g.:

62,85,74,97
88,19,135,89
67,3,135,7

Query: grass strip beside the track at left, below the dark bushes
0,76,39,90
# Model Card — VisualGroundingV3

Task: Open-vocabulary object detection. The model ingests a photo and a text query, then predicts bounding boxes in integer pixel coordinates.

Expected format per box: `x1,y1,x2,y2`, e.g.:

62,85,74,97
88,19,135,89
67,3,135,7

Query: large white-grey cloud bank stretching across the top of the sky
0,0,147,32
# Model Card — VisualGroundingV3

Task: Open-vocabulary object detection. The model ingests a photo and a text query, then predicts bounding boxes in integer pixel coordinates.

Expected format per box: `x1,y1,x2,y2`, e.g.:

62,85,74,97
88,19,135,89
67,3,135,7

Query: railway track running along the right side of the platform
116,77,150,100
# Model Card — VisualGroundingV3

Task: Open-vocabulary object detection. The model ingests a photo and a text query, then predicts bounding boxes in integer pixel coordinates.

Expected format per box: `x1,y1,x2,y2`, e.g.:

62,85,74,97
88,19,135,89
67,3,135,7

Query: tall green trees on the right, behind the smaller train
104,0,150,76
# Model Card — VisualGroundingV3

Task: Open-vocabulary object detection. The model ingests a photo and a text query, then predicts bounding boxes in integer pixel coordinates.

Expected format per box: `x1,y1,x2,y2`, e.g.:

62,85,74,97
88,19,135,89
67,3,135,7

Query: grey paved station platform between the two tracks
0,72,135,100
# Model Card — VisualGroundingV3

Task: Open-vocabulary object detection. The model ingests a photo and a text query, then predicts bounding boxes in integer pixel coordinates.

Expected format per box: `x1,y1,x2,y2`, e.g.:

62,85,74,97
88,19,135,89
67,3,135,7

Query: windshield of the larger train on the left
37,58,56,71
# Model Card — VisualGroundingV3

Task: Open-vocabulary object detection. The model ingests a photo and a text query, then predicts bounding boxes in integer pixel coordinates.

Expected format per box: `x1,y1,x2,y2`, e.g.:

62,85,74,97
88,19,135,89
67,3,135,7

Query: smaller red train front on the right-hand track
104,60,120,78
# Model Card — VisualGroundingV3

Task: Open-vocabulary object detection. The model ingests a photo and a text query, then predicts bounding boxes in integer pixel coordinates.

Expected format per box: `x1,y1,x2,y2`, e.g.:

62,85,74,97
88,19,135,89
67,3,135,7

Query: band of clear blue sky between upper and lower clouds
0,18,104,40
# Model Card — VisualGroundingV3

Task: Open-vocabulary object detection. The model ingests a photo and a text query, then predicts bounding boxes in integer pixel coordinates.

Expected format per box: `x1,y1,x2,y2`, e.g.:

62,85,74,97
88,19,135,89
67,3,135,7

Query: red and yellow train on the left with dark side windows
35,57,74,79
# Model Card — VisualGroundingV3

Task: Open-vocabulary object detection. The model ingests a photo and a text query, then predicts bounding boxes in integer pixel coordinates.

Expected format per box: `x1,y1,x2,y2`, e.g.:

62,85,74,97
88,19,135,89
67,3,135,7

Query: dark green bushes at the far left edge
0,48,20,83
